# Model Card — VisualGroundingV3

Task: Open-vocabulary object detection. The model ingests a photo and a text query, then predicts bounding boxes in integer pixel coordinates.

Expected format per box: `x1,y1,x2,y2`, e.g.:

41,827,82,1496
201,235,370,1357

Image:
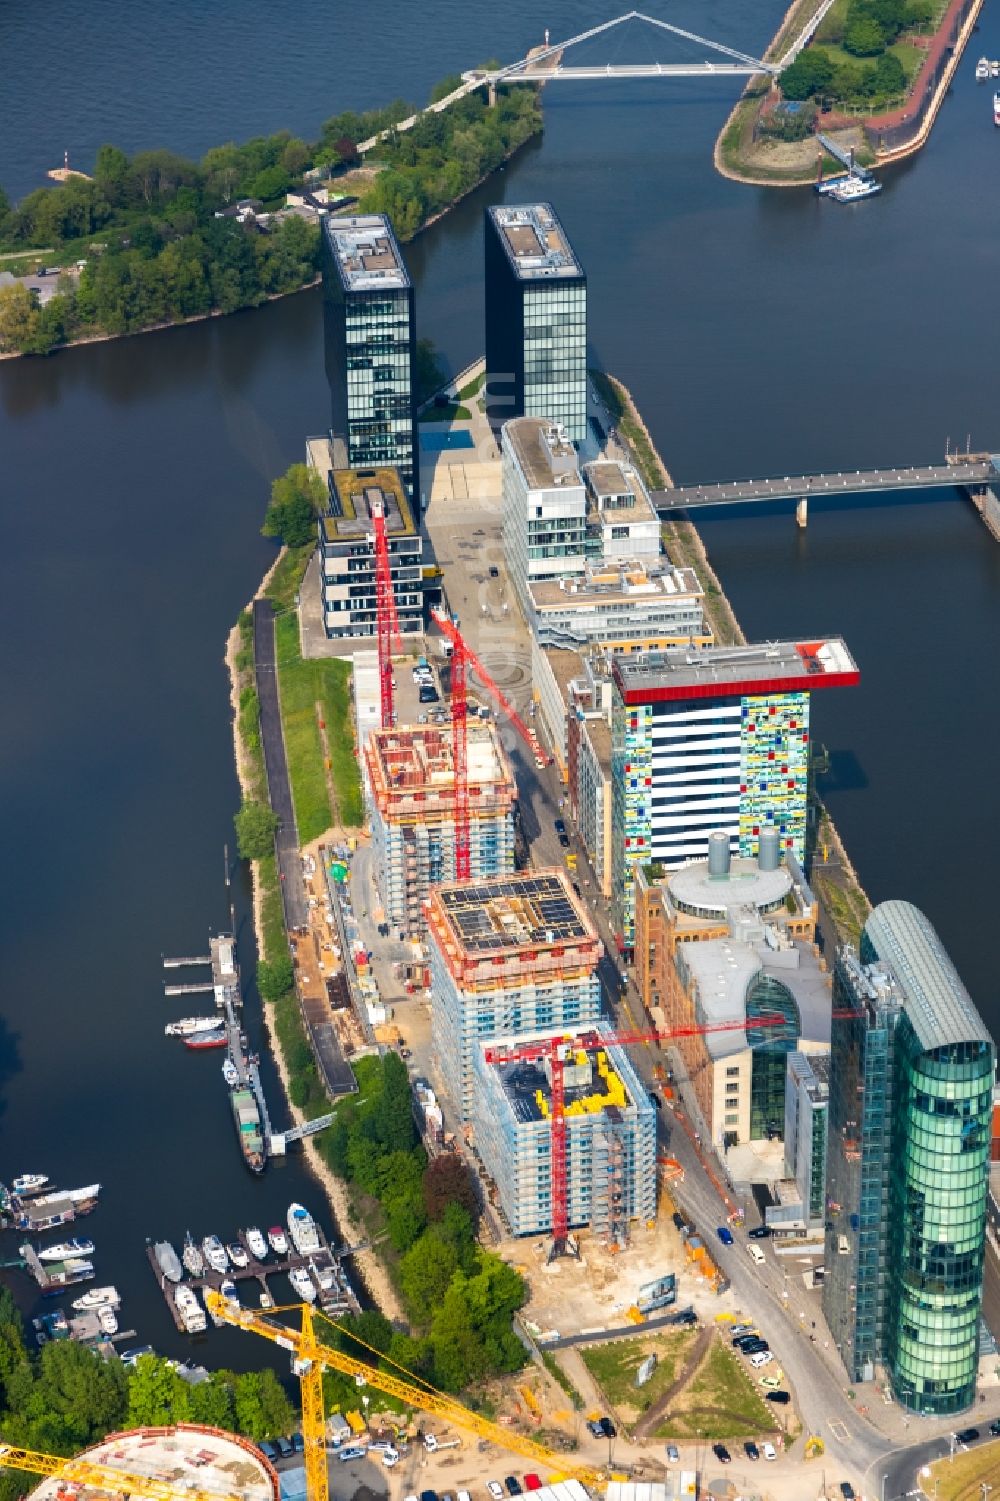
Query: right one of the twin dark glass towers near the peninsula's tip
485,203,587,443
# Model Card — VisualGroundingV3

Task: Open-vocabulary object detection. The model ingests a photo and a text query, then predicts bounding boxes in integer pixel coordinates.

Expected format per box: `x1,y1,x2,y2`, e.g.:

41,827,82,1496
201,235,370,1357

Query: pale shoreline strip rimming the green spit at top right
713,0,983,188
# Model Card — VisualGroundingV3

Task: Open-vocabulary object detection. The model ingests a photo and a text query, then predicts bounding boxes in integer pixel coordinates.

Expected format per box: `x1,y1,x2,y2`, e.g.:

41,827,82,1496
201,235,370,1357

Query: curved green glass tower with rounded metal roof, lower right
823,902,995,1415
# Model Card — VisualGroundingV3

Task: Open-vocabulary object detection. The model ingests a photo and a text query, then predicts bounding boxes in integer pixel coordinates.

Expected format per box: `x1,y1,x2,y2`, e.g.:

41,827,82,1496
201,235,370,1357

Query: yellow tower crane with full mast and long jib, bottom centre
204,1288,602,1501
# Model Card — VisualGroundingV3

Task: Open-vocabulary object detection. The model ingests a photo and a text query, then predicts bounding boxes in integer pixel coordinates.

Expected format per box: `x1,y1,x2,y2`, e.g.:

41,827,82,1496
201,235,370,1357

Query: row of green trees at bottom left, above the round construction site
0,1288,297,1482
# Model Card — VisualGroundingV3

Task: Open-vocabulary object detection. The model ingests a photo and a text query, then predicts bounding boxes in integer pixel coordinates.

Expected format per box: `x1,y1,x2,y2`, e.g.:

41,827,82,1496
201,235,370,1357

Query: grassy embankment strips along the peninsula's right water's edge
603,372,871,946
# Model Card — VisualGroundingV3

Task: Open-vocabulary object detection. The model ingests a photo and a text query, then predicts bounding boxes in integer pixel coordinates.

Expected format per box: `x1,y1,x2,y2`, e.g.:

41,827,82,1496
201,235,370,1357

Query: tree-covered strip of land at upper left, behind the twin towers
0,78,542,354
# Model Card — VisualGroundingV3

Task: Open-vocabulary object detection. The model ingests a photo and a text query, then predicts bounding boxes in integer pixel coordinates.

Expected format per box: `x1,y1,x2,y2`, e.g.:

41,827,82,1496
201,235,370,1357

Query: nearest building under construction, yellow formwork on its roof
473,1028,656,1247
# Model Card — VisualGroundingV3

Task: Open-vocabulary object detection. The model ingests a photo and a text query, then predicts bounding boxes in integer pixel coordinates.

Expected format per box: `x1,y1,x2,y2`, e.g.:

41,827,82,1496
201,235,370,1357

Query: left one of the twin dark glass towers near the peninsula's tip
323,213,420,516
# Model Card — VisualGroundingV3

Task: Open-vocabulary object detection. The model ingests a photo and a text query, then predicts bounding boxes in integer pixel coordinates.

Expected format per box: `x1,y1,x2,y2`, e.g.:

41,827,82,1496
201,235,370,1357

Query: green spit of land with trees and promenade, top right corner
715,0,979,186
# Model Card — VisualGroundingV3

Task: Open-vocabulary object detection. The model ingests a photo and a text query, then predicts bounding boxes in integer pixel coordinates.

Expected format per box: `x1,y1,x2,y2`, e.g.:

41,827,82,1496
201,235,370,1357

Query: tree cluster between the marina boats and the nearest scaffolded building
320,1052,526,1391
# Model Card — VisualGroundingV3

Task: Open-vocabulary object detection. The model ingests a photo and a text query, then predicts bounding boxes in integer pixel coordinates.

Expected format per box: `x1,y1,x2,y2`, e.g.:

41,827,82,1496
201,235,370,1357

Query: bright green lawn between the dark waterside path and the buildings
275,611,362,844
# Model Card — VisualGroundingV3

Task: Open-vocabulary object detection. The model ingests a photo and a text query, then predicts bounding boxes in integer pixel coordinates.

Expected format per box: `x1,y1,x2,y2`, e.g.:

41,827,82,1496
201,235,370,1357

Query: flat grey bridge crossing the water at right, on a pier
650,453,1000,512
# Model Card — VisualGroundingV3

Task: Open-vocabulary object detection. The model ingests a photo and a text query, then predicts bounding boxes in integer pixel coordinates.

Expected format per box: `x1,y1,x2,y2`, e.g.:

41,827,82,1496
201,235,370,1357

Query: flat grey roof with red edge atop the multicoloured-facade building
613,636,860,704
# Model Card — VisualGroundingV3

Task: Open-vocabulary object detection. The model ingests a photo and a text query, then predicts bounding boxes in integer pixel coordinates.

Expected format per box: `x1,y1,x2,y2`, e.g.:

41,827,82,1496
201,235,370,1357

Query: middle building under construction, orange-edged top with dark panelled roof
425,871,602,1121
